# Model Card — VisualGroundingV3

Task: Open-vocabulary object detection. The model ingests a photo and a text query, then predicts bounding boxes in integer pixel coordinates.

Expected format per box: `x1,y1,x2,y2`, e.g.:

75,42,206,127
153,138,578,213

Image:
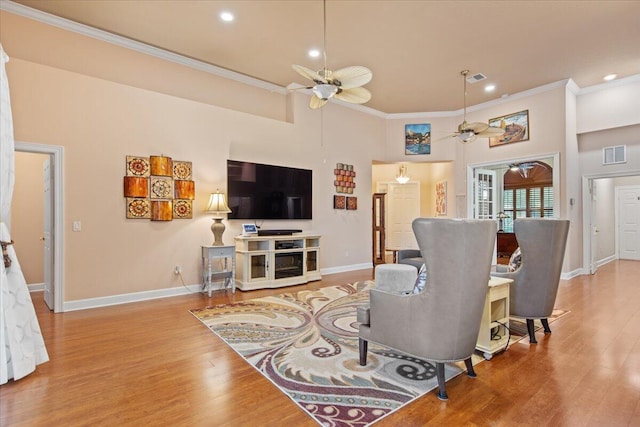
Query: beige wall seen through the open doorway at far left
11,153,49,285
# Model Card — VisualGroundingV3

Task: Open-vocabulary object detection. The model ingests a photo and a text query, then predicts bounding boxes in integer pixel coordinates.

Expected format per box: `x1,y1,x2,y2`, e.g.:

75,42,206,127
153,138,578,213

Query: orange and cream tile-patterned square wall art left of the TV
124,155,195,221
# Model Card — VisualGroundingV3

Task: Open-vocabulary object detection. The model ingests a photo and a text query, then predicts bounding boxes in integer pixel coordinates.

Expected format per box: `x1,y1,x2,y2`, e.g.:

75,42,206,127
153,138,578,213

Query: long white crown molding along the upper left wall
0,0,287,95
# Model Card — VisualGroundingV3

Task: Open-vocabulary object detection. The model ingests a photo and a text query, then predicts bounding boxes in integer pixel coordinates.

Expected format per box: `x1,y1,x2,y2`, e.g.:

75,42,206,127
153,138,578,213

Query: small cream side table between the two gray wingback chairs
476,277,513,360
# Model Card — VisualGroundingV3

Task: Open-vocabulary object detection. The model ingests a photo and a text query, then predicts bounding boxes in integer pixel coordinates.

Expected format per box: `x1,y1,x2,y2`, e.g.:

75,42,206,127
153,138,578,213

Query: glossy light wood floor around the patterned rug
0,261,640,427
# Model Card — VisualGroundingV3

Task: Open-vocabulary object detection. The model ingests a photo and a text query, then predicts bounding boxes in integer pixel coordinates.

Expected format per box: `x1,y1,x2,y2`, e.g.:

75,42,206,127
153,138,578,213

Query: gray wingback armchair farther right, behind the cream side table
492,218,569,344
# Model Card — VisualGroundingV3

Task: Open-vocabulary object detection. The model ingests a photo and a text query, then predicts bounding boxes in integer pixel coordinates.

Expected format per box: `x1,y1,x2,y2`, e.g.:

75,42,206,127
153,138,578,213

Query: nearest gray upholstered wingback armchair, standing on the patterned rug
358,218,497,400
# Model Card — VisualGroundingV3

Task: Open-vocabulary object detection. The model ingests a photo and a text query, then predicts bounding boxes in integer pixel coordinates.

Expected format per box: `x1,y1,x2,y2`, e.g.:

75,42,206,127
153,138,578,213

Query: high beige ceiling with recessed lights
8,0,640,114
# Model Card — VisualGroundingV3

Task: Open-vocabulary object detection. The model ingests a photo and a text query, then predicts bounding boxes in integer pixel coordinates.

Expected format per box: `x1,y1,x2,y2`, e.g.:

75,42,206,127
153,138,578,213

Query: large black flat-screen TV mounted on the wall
227,160,312,220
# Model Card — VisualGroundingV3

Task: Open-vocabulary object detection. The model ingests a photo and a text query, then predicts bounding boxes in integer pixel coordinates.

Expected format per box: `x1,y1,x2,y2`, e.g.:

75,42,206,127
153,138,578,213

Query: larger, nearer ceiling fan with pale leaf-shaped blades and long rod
292,0,373,109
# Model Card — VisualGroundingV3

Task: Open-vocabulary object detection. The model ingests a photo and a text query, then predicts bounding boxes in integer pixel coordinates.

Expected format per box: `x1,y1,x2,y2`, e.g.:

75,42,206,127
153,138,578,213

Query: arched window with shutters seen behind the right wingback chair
502,161,553,233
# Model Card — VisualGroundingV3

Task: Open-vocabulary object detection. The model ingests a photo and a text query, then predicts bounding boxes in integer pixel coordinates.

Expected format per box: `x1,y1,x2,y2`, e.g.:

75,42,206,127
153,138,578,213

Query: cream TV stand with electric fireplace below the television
236,233,322,291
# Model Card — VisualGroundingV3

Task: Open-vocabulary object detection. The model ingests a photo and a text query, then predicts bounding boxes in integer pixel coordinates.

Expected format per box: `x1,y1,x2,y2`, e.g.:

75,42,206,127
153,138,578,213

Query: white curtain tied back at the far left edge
0,44,49,384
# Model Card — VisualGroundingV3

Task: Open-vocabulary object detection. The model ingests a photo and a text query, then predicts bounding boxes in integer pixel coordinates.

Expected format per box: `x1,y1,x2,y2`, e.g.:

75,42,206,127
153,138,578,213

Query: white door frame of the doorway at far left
15,141,64,313
